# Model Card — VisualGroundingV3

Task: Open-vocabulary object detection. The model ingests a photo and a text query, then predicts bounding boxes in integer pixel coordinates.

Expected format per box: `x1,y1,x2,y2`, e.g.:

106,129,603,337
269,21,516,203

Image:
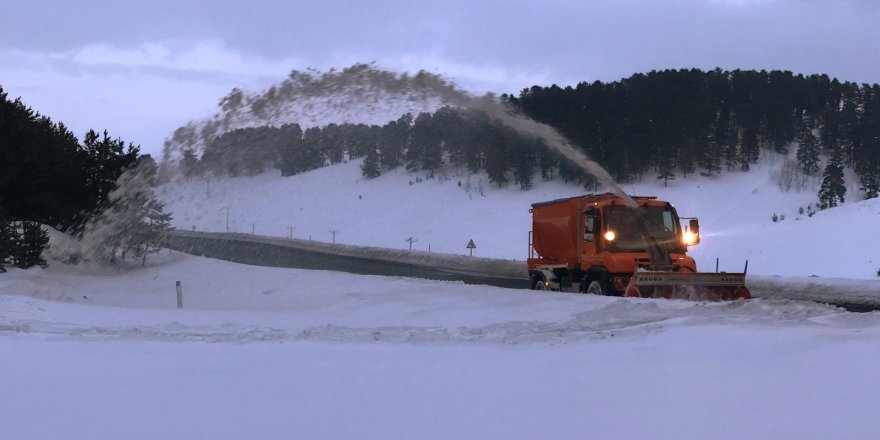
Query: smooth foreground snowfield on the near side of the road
0,253,880,439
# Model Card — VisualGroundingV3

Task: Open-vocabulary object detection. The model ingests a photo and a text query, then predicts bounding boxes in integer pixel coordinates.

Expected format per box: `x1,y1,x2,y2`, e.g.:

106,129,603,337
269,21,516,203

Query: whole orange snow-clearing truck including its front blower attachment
528,193,751,301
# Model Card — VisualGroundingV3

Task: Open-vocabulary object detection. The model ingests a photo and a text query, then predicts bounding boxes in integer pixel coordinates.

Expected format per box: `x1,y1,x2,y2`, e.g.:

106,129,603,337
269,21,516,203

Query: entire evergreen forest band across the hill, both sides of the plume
167,69,880,205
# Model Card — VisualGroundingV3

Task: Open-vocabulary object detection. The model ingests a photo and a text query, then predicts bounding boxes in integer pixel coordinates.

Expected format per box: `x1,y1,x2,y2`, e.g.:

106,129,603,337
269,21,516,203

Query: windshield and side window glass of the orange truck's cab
605,206,682,251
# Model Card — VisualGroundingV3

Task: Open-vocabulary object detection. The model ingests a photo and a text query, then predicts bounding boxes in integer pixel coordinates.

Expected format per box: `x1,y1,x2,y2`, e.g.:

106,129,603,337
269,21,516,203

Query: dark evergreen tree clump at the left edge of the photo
0,88,163,267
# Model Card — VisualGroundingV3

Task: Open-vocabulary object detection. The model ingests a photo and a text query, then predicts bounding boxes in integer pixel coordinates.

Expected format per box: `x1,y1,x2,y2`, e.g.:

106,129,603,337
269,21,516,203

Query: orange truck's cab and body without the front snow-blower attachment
527,193,699,295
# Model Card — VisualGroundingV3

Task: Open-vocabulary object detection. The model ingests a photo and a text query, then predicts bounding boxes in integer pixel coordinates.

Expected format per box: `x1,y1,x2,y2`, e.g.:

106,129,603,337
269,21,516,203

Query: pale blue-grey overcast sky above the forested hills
0,0,880,156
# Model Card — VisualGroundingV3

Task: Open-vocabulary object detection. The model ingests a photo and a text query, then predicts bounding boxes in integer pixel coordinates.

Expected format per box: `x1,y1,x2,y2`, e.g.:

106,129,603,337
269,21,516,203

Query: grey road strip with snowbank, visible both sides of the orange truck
166,230,880,312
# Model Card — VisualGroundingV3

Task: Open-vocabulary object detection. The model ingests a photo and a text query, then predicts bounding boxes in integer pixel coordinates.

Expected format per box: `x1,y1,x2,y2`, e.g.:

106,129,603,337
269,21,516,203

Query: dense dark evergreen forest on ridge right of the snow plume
507,69,878,198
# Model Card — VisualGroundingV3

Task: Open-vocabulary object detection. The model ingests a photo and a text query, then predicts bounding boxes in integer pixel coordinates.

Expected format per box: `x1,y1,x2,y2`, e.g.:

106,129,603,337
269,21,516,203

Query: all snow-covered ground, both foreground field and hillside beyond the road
0,155,880,439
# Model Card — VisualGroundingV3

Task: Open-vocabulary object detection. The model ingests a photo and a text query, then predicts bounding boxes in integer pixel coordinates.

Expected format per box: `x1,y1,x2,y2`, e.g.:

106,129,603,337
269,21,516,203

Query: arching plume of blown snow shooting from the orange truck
162,64,636,207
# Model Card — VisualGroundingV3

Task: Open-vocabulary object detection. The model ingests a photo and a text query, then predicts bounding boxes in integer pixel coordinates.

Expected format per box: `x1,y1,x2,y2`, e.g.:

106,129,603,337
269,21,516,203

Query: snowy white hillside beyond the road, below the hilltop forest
158,156,880,279
